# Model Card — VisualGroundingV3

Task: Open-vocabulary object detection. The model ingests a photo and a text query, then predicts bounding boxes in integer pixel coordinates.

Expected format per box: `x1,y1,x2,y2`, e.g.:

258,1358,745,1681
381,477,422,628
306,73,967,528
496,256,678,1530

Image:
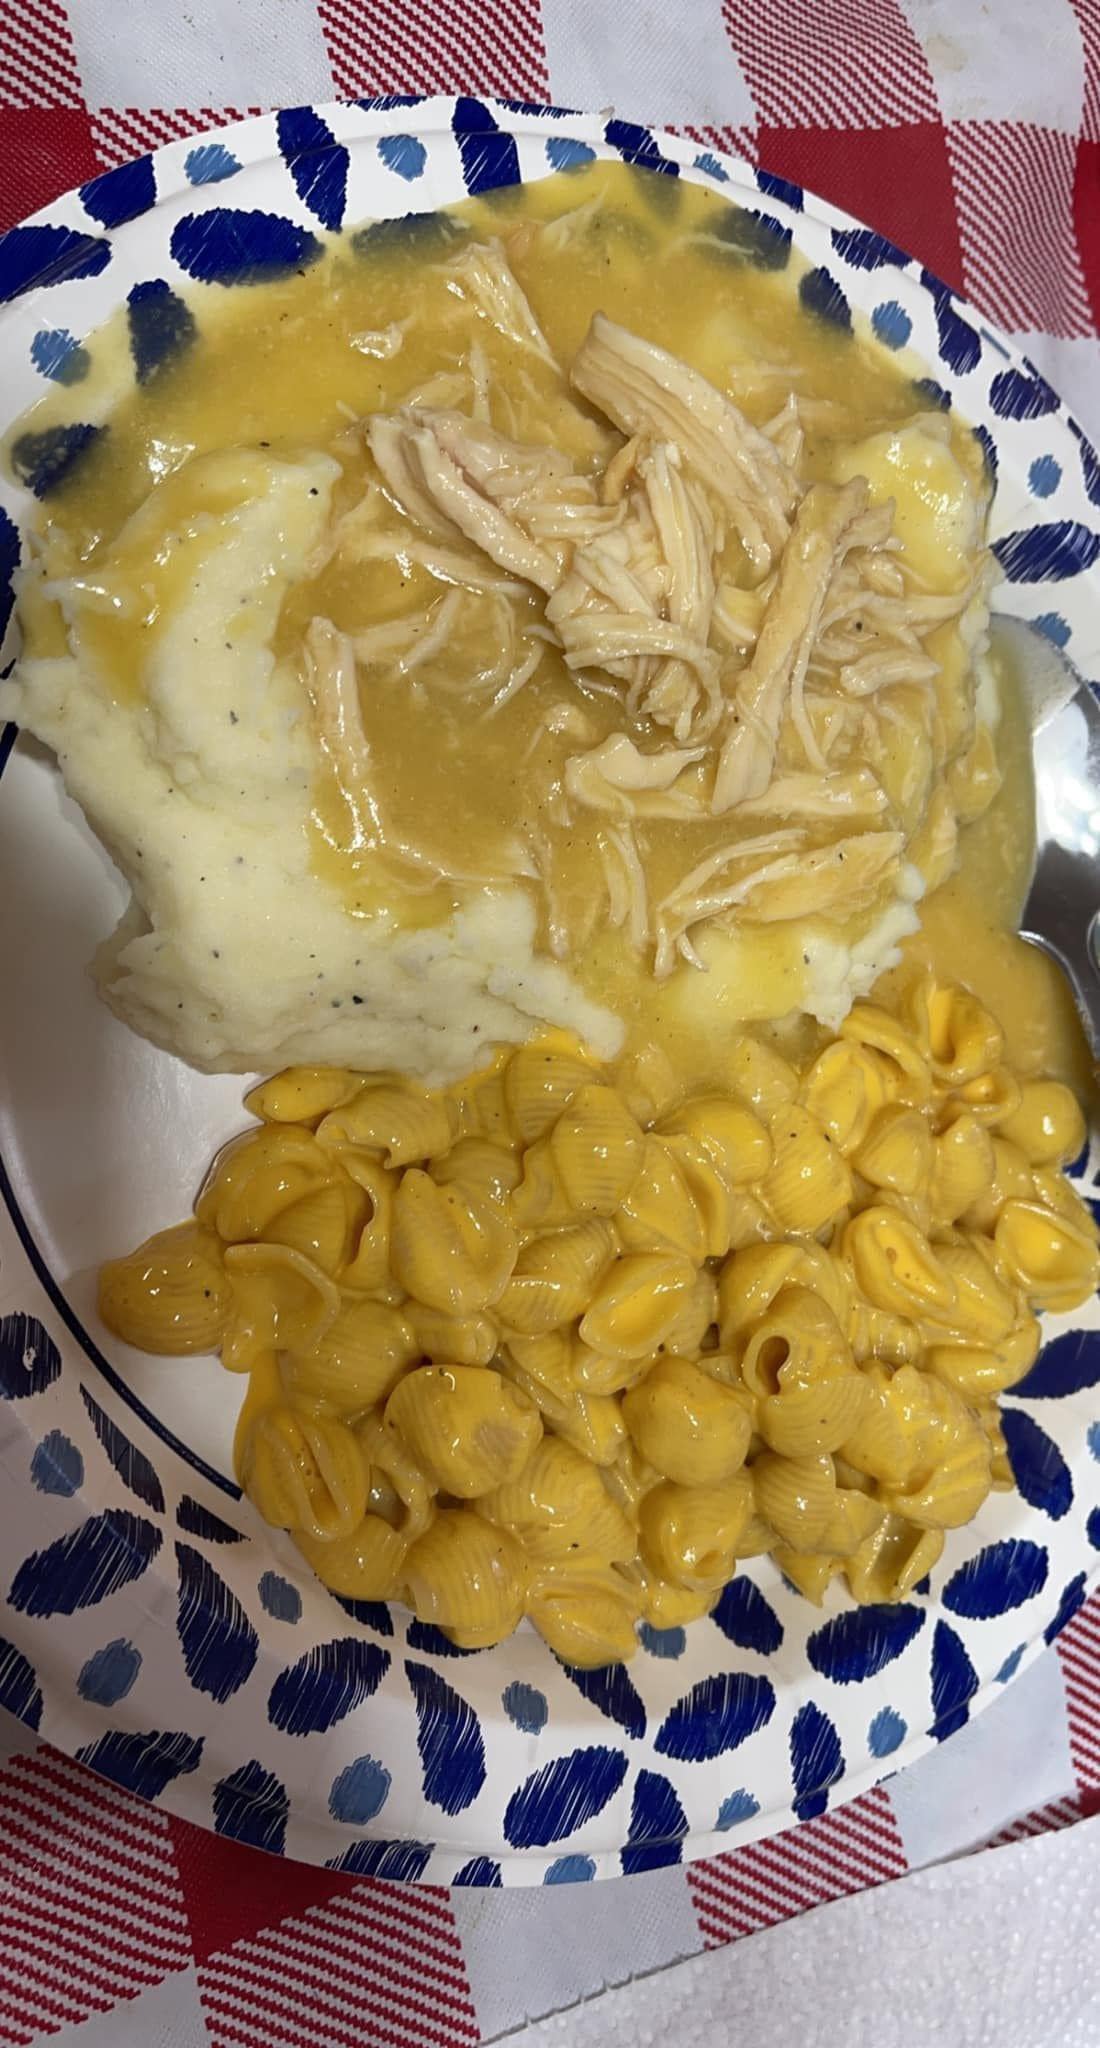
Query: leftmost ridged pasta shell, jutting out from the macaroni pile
98,1223,234,1358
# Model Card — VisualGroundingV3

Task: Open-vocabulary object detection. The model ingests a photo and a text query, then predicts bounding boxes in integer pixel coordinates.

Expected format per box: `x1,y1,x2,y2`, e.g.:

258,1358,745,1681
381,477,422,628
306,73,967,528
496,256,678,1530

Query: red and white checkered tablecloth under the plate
0,0,1100,2048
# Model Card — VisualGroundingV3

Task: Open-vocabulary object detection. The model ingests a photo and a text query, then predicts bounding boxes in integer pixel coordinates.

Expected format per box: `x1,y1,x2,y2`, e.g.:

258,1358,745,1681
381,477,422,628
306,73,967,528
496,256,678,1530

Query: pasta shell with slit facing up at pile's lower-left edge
240,1407,367,1542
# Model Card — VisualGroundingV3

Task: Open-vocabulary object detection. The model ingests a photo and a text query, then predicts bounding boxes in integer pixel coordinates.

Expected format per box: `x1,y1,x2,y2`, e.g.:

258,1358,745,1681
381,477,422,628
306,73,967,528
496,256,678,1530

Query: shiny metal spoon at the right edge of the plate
993,614,1100,1059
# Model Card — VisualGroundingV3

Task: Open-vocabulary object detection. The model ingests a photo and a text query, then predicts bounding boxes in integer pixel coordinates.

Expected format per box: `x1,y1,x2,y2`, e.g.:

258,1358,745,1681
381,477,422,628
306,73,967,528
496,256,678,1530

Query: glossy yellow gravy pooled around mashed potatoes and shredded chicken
8,164,1088,1087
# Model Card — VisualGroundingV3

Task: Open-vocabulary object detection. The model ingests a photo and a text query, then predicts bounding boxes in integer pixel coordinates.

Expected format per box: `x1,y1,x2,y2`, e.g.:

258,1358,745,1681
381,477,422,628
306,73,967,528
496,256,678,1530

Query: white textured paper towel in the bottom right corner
497,1819,1100,2048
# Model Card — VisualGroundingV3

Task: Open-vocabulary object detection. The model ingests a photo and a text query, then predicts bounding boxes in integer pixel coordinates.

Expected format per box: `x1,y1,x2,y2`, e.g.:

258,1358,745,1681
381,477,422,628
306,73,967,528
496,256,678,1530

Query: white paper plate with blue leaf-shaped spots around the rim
0,98,1100,1884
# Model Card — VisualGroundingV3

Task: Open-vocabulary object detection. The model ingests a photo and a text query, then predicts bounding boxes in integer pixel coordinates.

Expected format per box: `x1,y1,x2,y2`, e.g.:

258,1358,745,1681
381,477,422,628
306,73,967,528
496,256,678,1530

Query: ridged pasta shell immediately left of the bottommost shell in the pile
406,1507,526,1649
